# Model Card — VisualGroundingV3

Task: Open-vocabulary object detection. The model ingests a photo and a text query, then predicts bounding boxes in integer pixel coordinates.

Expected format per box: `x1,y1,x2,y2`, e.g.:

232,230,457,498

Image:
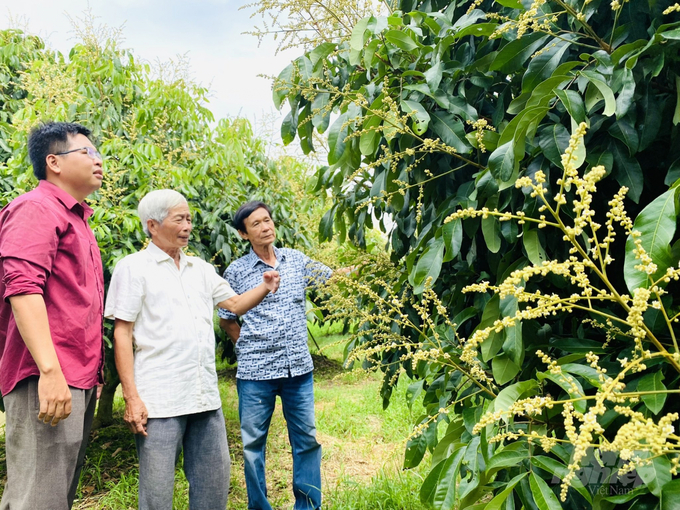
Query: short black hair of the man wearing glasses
28,122,91,180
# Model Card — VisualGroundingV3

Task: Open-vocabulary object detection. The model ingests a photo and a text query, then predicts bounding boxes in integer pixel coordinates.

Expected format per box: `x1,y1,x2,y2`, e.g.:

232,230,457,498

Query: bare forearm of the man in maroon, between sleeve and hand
9,294,61,374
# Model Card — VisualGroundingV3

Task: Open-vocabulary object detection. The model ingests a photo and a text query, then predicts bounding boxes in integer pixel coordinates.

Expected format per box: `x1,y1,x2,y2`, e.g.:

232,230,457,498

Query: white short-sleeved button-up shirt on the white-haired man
104,243,236,418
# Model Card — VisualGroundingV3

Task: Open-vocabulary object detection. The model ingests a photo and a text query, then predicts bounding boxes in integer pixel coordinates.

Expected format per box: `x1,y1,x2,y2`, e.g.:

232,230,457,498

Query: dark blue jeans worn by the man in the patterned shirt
236,372,321,510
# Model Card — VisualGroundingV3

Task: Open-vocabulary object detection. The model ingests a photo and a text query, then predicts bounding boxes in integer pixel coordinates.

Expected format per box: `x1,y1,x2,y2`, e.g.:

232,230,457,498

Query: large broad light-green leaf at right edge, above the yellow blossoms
623,188,678,294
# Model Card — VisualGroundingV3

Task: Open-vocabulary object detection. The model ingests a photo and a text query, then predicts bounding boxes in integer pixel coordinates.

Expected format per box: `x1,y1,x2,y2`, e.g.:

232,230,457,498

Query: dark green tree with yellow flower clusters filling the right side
274,0,680,509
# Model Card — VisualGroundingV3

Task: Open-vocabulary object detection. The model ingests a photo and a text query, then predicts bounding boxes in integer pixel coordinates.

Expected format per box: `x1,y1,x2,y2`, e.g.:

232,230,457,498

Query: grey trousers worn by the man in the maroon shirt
0,377,97,510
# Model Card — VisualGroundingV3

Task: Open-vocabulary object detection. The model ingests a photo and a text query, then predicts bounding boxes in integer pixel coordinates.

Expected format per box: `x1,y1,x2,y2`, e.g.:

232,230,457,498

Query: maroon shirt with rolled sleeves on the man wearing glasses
0,180,104,395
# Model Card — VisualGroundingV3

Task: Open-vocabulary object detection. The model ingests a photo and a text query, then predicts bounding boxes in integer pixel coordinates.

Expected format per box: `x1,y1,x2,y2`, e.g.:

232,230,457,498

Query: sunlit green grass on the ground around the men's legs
0,332,426,510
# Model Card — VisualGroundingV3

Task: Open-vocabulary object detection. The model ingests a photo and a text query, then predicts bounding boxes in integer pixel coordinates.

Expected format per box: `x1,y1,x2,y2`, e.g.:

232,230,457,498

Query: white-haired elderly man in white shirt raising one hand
104,190,279,510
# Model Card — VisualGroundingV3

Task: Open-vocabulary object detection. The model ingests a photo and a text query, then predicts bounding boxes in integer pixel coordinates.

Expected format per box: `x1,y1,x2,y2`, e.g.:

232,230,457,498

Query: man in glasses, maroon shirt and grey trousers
0,122,104,510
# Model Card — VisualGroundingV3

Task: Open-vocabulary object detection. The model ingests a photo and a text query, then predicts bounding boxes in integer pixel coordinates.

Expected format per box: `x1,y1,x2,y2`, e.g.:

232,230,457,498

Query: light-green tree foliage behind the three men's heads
0,25,310,422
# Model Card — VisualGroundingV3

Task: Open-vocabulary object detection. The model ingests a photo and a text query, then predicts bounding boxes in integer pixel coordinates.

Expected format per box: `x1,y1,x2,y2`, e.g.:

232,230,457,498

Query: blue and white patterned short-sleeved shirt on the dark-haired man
218,248,332,381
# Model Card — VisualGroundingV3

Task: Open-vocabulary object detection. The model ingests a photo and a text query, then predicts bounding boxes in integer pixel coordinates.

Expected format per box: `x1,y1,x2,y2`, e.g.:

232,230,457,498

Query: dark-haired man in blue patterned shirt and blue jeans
219,202,332,510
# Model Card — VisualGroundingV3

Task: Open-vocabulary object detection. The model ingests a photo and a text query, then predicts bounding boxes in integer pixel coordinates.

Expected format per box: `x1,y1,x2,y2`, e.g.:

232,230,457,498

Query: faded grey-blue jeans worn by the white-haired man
135,409,231,510
